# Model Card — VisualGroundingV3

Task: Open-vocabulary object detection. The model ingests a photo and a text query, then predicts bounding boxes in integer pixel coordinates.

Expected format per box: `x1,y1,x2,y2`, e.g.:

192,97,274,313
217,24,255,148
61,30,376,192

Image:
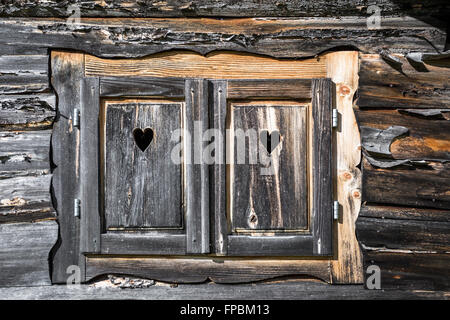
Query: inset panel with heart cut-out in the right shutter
230,103,308,232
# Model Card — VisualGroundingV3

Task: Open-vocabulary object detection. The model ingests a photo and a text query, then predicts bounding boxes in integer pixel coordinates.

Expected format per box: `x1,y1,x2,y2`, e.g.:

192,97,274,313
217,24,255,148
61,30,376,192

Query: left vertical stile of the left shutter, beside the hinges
79,78,101,253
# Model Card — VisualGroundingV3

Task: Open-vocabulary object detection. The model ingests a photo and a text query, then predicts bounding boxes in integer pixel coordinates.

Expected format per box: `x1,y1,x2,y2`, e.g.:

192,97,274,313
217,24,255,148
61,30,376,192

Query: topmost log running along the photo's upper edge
0,0,448,18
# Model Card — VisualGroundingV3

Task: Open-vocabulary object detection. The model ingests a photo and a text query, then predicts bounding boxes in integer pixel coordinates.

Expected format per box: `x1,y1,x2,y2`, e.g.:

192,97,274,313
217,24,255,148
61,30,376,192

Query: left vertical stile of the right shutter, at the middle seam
209,80,228,255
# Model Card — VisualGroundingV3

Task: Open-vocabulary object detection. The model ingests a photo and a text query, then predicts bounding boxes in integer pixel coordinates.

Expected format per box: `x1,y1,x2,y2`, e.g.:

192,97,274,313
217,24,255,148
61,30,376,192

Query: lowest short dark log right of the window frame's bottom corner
364,251,450,292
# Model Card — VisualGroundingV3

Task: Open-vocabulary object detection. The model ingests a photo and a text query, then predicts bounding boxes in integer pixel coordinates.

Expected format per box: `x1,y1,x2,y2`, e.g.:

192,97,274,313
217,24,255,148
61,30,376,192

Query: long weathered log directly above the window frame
0,17,446,58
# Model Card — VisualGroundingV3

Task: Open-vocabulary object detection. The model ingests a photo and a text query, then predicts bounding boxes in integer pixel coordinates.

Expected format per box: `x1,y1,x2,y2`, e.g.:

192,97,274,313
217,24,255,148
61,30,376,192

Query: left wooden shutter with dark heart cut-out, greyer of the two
80,77,209,255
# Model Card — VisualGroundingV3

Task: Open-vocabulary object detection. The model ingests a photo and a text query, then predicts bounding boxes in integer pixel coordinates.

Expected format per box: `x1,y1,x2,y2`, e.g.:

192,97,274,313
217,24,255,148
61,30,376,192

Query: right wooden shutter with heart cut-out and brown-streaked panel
211,79,334,256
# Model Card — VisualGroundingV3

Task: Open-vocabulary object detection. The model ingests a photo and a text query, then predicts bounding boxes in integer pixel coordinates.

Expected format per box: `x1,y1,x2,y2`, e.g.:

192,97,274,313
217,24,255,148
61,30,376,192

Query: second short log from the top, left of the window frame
0,94,56,130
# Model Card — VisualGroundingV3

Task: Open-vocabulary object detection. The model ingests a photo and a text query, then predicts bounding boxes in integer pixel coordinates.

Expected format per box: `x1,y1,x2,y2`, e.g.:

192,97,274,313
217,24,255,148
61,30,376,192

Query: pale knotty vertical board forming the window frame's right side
326,51,363,283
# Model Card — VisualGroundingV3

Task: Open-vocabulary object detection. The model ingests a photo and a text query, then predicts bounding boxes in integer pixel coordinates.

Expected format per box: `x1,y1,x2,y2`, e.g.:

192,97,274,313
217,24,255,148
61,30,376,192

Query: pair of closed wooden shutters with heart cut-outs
80,77,334,256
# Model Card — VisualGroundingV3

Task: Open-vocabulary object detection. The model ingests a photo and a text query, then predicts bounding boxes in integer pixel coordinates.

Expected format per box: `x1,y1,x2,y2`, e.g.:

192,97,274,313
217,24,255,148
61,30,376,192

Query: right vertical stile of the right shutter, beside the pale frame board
311,79,334,255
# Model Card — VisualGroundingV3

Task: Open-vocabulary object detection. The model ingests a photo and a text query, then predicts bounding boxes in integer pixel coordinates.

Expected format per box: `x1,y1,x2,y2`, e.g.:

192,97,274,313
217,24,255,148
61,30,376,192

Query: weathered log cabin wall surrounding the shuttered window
0,0,450,289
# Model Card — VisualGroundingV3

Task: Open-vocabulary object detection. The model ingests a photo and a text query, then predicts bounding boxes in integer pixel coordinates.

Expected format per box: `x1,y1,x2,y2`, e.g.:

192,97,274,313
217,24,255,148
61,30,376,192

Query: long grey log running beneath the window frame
0,280,448,302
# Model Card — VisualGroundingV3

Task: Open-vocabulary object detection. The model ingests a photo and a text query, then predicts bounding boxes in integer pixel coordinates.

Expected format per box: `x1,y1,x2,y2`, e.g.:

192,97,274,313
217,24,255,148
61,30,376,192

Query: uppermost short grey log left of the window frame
0,55,49,94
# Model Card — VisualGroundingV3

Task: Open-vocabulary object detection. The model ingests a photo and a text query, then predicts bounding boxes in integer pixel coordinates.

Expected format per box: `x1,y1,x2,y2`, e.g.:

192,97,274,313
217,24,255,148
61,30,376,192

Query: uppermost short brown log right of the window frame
358,54,450,109
